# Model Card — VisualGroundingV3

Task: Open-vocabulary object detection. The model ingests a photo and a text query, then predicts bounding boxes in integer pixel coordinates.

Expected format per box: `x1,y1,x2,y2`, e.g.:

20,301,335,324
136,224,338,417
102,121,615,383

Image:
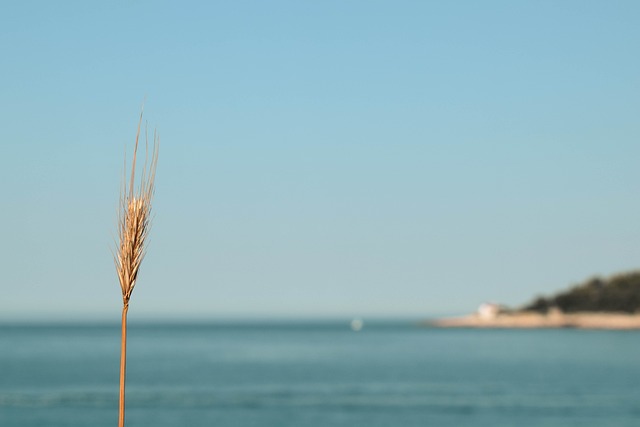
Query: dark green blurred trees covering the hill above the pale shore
523,271,640,313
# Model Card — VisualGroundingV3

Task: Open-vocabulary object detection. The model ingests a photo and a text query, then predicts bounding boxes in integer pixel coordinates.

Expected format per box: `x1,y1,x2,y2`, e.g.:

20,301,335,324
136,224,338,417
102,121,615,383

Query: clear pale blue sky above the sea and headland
0,0,640,319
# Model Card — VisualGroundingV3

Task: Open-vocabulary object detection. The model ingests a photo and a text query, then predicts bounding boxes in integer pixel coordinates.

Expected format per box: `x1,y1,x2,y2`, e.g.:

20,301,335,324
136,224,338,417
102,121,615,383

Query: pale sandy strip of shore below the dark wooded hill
428,312,640,330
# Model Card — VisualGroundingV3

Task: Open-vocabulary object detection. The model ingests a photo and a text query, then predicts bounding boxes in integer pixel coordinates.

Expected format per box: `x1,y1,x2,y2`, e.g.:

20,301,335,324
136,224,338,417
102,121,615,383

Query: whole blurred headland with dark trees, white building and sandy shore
428,271,640,329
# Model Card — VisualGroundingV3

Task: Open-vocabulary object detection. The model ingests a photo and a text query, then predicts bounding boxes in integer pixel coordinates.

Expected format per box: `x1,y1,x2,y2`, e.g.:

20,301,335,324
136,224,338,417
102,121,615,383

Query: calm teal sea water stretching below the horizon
0,322,640,427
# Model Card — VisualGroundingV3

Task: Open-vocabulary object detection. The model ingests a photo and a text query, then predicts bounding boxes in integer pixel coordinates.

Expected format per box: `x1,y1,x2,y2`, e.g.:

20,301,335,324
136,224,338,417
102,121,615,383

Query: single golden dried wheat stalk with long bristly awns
113,112,159,427
